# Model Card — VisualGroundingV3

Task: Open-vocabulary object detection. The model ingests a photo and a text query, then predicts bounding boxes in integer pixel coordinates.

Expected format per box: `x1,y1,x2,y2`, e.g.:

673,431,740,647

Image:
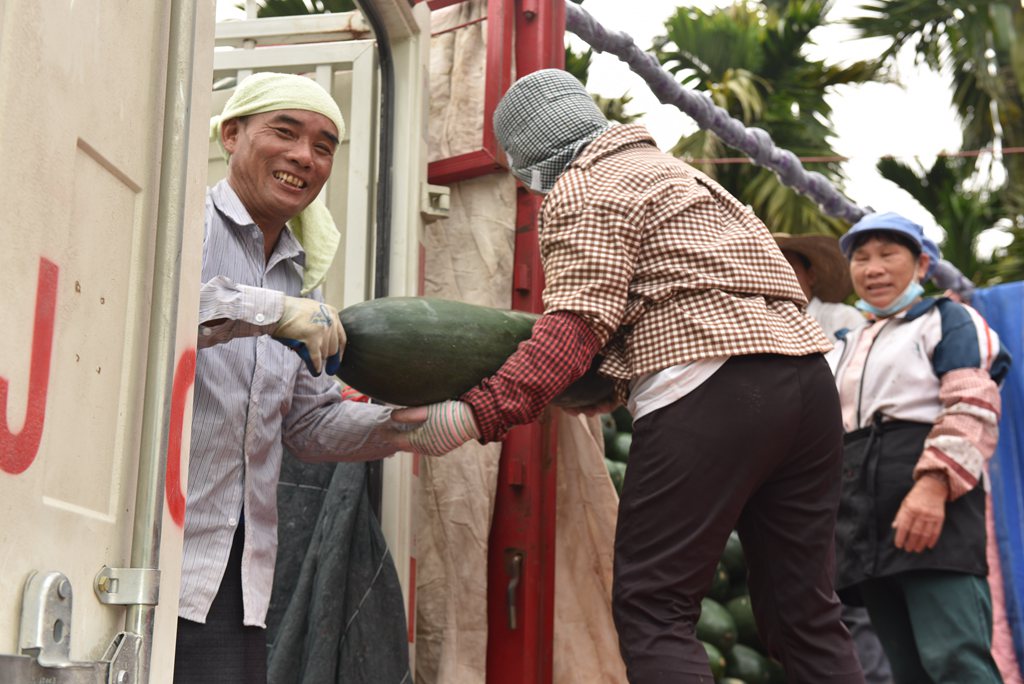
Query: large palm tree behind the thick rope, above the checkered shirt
654,0,883,236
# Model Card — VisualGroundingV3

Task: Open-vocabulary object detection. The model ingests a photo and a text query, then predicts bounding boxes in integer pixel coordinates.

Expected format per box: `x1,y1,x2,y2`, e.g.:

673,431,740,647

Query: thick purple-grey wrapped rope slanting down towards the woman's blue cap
565,2,974,300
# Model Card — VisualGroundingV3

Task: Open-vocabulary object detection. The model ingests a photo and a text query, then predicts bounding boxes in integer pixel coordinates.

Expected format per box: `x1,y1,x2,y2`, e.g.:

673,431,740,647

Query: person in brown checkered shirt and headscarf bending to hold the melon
394,70,864,684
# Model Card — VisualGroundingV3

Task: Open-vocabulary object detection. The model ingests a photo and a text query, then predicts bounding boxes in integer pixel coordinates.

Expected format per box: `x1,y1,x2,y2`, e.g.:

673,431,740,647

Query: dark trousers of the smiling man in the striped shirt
174,523,266,684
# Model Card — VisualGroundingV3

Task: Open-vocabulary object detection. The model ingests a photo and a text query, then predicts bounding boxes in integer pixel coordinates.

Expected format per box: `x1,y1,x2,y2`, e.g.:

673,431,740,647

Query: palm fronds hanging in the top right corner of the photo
851,0,1024,212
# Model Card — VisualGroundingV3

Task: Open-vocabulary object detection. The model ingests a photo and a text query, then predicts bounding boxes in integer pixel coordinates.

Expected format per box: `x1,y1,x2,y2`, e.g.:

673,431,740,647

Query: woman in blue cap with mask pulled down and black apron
828,212,1010,683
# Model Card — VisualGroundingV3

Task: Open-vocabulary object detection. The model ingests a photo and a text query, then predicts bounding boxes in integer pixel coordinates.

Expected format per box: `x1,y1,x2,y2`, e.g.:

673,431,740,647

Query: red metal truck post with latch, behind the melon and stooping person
487,0,565,684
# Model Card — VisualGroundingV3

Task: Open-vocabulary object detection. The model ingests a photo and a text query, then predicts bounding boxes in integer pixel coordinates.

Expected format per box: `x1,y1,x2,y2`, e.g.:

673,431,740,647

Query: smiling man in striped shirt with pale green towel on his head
174,74,395,684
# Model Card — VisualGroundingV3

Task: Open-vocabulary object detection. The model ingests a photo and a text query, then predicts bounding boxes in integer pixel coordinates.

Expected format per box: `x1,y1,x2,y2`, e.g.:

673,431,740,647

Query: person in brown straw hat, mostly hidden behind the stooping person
774,232,864,342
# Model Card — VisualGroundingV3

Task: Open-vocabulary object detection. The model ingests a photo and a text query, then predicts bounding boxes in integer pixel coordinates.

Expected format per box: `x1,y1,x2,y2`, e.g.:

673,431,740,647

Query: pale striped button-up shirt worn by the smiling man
178,180,394,627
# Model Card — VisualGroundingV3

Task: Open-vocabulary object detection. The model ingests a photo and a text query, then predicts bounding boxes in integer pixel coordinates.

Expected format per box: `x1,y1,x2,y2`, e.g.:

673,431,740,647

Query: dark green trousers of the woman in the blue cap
860,570,1002,684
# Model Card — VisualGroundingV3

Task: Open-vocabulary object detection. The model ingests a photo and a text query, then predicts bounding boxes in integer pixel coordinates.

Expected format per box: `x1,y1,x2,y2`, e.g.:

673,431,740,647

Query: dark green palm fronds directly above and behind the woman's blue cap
878,156,1005,285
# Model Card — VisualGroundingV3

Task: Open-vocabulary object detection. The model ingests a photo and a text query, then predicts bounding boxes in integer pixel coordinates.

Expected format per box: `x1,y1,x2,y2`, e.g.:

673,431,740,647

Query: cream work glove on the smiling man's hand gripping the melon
271,297,345,376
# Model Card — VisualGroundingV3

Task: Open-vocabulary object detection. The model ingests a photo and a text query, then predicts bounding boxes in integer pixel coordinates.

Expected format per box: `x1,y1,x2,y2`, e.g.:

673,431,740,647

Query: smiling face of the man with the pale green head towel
221,110,339,229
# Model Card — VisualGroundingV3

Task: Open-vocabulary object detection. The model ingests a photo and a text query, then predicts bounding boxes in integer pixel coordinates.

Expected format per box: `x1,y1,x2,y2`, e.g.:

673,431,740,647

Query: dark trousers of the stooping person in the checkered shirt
612,354,864,684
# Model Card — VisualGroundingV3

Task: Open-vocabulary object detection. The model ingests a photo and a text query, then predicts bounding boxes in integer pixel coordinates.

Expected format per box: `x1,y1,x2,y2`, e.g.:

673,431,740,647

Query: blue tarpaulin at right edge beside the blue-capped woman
971,283,1024,662
